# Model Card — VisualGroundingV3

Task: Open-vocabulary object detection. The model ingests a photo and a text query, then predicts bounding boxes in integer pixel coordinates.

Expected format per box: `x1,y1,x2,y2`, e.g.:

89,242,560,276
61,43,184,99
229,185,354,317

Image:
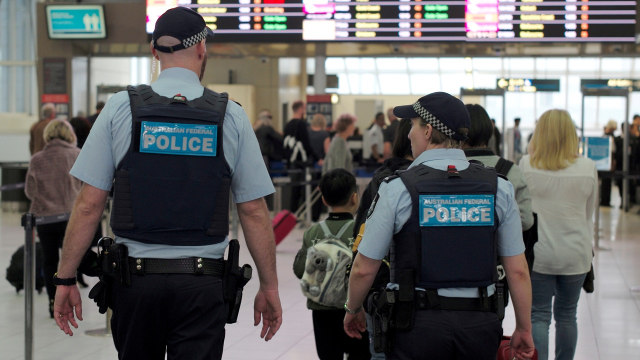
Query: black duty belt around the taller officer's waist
129,257,225,276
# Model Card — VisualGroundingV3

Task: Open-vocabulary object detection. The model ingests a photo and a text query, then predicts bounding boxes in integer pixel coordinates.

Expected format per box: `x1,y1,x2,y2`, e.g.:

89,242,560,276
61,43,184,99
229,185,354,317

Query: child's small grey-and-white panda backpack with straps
300,220,353,308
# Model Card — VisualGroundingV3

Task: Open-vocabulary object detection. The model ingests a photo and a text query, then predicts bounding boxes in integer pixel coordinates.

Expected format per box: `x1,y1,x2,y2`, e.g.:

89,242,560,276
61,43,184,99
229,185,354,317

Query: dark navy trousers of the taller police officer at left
111,274,227,360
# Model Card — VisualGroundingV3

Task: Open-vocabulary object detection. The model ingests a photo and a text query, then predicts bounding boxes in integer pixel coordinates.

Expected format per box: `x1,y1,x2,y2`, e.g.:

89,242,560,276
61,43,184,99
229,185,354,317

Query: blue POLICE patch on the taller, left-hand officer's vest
140,121,218,156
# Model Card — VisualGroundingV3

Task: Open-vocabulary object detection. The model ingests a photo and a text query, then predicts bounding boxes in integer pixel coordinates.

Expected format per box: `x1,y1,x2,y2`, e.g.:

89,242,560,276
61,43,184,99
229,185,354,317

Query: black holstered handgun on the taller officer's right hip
222,239,253,324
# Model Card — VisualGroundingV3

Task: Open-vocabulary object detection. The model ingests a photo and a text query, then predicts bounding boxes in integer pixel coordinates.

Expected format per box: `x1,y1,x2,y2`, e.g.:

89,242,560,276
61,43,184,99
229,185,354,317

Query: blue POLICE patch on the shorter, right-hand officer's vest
419,195,495,226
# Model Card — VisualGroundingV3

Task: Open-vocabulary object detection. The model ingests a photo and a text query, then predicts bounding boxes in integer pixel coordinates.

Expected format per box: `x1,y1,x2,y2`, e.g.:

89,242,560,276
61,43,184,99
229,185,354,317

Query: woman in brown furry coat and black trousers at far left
24,119,82,317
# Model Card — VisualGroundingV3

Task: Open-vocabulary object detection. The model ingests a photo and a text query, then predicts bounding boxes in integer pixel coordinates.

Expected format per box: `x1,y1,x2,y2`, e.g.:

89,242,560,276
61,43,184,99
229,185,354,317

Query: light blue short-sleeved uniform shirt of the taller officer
70,68,274,259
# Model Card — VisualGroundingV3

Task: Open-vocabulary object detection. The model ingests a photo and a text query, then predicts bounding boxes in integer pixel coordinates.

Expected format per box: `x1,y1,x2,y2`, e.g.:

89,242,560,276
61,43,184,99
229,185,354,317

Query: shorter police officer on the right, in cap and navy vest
344,92,534,360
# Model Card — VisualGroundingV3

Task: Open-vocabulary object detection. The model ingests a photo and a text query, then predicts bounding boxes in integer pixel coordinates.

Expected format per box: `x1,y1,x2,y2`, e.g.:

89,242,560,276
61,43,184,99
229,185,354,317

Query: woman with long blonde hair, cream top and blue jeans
520,110,598,360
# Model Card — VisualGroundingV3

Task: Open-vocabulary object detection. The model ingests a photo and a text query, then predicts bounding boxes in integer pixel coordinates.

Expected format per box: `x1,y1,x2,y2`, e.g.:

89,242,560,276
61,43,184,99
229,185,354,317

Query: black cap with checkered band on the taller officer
152,7,213,53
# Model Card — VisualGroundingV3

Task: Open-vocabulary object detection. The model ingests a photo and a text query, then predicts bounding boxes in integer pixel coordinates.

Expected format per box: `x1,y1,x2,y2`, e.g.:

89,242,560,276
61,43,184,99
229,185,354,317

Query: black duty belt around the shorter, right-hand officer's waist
416,290,496,311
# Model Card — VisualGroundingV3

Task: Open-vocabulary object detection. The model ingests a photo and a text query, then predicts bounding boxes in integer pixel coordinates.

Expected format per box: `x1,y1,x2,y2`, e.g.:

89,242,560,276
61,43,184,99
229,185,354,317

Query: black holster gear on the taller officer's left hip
89,237,131,314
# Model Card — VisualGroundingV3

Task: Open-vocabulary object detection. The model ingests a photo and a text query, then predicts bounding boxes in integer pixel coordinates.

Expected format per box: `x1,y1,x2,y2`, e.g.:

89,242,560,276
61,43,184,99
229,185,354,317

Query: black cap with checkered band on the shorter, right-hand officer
393,92,471,140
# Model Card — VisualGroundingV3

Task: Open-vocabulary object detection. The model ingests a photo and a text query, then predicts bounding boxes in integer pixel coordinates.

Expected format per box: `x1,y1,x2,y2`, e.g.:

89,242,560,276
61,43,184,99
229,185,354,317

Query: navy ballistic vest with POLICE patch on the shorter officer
391,163,498,289
